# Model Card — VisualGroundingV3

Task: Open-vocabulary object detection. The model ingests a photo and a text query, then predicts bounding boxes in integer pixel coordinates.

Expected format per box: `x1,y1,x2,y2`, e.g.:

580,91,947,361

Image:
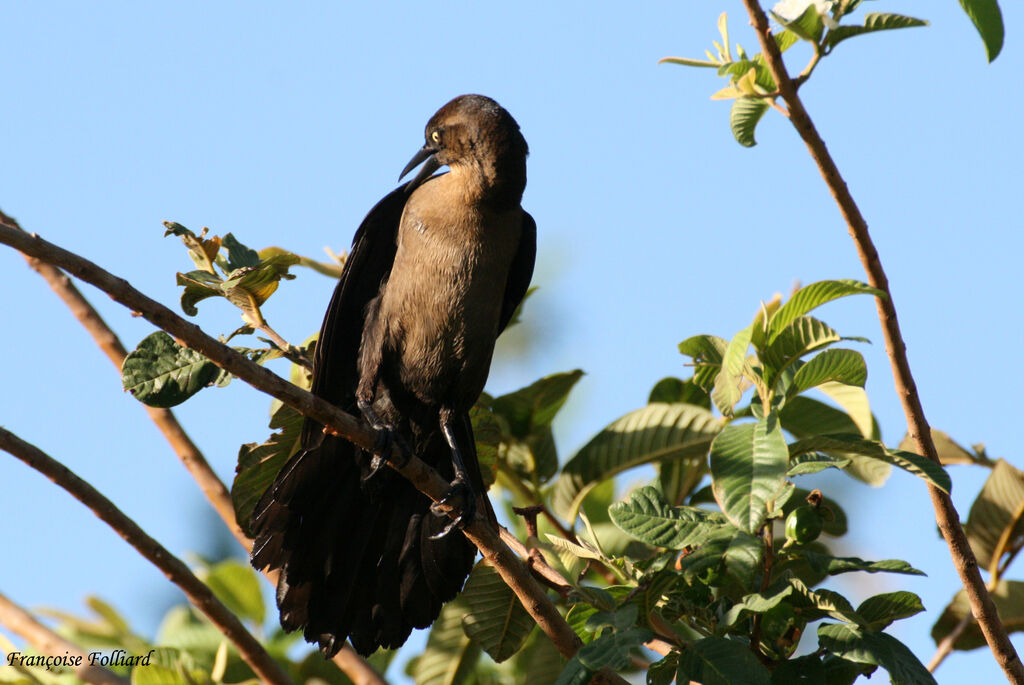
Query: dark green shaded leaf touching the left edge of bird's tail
231,404,303,536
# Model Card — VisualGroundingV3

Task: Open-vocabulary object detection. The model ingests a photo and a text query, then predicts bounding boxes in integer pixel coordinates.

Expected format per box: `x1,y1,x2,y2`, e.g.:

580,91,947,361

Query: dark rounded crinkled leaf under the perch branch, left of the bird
121,331,221,408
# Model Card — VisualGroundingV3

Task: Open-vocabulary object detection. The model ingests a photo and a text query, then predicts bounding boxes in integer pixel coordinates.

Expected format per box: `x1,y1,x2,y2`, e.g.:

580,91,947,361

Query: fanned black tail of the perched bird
250,421,494,656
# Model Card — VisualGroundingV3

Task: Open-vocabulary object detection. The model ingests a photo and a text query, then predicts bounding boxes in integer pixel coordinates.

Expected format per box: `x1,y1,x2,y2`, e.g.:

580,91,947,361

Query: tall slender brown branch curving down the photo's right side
743,0,1024,683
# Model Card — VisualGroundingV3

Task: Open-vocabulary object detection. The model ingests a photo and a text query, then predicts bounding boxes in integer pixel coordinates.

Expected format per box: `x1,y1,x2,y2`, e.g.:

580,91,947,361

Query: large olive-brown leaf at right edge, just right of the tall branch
966,459,1024,572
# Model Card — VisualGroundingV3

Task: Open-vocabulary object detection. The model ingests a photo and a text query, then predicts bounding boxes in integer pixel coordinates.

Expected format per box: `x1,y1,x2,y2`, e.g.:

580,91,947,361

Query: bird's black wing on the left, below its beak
302,185,409,446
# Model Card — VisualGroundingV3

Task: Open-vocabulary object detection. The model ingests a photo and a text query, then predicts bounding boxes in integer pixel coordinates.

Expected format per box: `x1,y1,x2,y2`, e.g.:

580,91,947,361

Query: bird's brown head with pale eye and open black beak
398,95,529,200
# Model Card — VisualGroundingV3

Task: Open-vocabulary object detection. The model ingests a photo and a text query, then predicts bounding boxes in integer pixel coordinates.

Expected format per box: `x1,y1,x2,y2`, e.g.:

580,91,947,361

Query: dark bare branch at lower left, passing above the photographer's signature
0,428,292,685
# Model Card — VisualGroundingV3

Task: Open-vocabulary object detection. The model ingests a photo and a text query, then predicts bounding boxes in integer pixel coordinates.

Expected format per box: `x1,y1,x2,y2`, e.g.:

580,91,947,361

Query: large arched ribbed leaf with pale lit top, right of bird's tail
552,403,722,521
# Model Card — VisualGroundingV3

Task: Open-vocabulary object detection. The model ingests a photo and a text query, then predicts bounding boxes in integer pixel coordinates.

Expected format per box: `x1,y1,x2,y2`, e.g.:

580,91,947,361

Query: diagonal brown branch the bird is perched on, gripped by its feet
0,222,580,657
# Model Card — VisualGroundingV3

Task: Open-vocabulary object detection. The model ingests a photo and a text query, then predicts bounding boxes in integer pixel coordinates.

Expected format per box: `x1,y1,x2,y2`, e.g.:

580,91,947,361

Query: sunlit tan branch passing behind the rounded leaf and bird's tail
0,212,385,685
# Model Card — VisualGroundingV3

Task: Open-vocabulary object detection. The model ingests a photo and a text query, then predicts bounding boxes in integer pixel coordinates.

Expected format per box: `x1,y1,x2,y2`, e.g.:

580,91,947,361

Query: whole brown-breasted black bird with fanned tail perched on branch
249,94,537,657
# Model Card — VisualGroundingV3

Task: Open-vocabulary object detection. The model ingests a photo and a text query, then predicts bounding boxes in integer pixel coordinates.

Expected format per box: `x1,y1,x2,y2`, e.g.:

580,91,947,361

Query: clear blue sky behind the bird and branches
0,0,1024,683
